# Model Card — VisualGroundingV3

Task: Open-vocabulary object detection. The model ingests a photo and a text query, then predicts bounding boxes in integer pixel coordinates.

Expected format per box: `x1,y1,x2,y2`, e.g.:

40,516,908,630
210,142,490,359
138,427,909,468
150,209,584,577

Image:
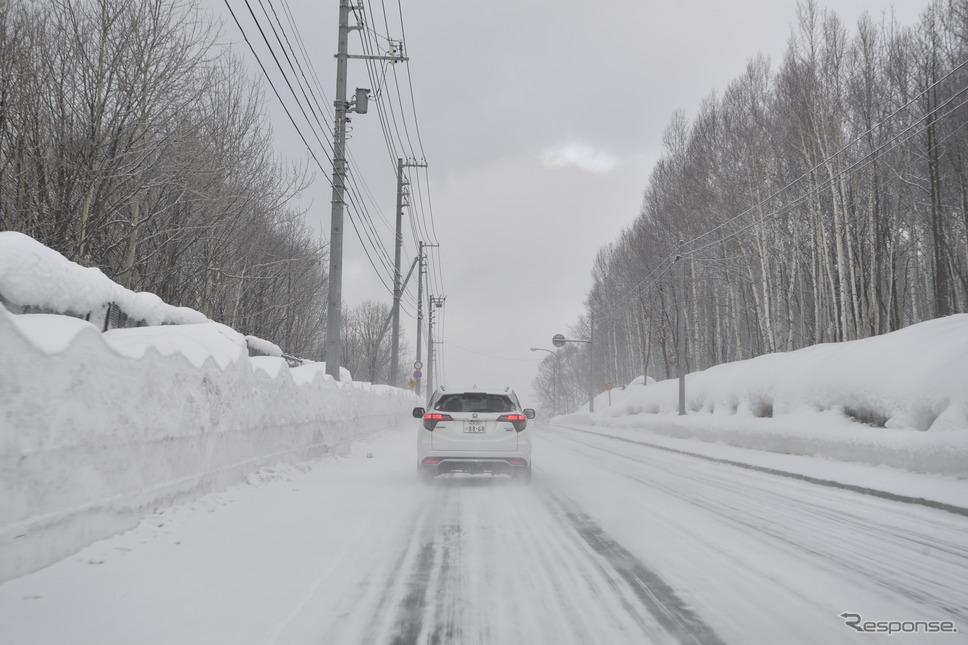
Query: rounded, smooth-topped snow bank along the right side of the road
559,314,968,476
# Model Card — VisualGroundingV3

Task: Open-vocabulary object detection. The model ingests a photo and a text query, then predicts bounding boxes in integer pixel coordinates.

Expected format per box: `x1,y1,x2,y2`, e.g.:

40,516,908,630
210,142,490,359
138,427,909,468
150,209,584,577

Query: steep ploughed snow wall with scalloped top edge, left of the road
0,306,416,582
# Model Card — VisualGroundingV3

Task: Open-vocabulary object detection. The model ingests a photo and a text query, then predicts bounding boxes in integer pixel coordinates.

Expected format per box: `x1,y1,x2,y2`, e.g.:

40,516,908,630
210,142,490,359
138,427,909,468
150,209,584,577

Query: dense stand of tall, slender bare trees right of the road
556,0,968,402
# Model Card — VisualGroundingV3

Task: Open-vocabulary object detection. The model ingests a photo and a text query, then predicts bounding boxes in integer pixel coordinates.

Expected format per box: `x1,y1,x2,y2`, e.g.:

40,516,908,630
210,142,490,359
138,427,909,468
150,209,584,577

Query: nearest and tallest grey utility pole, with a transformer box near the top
326,0,407,381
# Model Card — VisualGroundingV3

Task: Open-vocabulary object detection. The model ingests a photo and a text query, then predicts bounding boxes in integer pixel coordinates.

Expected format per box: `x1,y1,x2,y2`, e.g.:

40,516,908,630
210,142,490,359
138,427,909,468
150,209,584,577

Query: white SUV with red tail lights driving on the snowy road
413,388,535,482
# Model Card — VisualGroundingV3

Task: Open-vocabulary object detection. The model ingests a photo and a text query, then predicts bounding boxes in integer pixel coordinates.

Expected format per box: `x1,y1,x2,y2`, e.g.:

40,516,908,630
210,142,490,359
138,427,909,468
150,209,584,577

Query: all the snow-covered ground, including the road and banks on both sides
0,233,968,645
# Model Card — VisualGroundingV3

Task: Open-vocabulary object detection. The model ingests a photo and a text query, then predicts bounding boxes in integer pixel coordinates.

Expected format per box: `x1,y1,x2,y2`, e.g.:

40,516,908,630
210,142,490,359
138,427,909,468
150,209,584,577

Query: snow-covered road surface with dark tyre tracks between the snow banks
0,427,968,645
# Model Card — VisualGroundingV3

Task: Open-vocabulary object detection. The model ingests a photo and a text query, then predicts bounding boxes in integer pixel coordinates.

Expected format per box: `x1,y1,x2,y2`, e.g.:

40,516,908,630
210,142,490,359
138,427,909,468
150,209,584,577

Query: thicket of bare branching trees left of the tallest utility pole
0,0,326,358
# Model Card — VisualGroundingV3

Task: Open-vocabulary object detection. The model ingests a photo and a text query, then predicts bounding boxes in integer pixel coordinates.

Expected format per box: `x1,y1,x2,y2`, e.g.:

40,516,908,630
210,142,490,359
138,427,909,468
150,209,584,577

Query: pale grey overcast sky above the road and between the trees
205,0,928,406
